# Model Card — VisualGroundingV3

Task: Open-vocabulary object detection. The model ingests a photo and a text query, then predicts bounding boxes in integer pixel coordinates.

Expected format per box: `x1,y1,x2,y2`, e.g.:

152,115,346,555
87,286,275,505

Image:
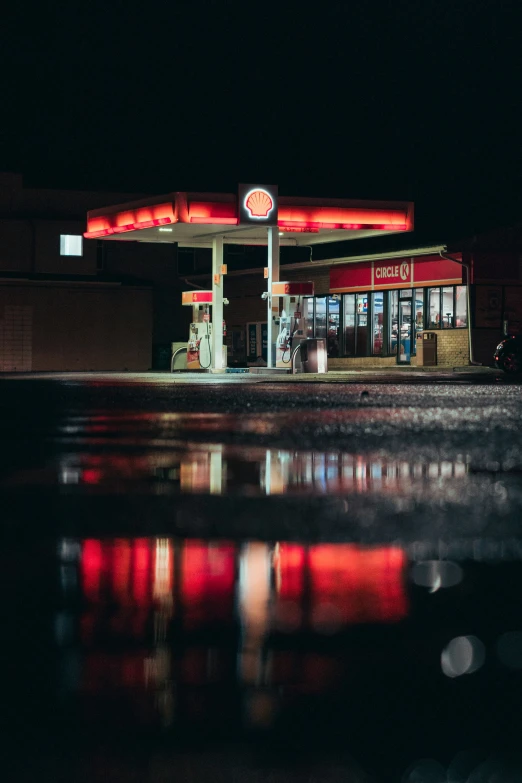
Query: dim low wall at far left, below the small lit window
0,283,152,372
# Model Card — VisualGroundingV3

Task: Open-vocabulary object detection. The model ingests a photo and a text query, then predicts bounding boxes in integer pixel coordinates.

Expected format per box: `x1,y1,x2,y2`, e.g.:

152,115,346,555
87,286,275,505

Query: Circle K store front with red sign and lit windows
298,256,469,366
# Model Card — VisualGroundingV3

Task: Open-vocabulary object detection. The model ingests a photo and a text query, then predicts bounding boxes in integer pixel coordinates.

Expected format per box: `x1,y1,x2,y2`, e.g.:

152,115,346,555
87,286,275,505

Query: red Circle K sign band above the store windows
330,256,462,293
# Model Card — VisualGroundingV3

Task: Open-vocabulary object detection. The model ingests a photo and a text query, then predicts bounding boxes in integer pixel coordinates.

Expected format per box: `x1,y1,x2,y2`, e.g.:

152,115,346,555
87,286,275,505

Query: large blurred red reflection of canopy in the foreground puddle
59,538,408,728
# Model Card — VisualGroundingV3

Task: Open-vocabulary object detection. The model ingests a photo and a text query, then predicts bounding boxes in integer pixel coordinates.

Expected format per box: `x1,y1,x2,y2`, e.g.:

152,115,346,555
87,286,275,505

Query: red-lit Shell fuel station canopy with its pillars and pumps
84,189,413,373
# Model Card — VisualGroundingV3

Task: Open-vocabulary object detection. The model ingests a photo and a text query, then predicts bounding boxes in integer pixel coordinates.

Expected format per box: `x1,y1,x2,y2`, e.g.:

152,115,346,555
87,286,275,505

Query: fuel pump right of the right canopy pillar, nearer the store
272,282,314,368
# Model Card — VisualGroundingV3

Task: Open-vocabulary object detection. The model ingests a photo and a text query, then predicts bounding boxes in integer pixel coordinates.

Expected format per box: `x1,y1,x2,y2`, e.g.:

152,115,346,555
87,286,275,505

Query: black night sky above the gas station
0,0,522,242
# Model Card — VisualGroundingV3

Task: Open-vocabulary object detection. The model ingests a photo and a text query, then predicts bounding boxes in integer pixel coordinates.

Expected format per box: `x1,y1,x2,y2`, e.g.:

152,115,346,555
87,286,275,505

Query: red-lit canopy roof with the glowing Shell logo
84,185,413,247
